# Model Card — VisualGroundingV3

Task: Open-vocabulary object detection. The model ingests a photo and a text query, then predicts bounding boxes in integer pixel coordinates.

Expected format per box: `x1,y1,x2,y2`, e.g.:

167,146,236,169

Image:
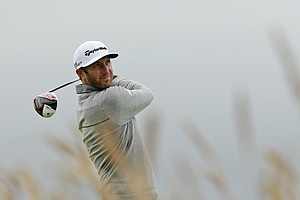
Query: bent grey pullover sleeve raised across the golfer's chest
102,77,153,125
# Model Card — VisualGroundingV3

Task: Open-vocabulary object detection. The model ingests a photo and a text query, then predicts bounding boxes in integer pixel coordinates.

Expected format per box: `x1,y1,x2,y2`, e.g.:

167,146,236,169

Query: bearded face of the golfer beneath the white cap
83,56,113,89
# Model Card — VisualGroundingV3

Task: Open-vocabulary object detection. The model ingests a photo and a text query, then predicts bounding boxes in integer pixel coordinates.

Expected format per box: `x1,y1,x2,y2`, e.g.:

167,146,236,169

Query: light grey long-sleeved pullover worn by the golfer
76,77,157,200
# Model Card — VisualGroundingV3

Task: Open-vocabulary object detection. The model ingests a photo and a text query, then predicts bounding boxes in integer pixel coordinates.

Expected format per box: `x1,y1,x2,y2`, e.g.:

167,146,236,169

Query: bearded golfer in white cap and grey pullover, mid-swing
73,41,157,200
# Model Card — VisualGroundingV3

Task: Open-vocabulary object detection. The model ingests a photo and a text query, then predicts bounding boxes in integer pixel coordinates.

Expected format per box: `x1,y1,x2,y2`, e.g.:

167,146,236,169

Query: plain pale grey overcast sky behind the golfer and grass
0,0,300,199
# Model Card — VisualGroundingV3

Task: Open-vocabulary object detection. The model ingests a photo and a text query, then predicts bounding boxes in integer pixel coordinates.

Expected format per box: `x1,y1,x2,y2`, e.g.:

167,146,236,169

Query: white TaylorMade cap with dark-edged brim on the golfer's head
73,41,119,70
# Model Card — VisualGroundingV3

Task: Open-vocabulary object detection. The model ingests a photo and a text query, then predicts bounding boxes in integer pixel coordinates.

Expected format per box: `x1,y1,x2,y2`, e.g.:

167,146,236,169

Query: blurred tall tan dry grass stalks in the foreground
0,28,300,200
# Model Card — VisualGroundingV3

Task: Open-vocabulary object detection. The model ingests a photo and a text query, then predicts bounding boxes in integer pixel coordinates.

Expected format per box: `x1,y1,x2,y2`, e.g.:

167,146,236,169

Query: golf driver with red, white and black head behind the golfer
33,79,80,118
